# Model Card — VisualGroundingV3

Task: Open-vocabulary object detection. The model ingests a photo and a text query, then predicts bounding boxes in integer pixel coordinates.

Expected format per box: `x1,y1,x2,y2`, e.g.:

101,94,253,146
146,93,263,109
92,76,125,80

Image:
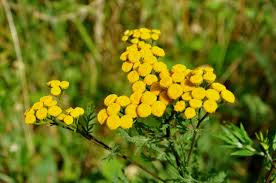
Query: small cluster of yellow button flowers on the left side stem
24,80,84,125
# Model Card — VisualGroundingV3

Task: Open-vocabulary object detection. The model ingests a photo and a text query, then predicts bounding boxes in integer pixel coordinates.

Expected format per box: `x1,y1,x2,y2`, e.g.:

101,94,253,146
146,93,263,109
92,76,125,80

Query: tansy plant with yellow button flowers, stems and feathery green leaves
25,28,274,182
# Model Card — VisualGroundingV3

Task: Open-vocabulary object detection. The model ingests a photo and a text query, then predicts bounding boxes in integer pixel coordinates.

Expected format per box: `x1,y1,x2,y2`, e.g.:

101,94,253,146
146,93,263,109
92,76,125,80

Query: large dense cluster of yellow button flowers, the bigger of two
98,28,235,129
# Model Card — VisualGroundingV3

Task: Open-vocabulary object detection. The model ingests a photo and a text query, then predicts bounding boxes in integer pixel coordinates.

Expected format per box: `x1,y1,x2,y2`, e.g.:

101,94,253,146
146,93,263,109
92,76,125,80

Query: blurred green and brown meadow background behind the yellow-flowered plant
0,0,276,182
